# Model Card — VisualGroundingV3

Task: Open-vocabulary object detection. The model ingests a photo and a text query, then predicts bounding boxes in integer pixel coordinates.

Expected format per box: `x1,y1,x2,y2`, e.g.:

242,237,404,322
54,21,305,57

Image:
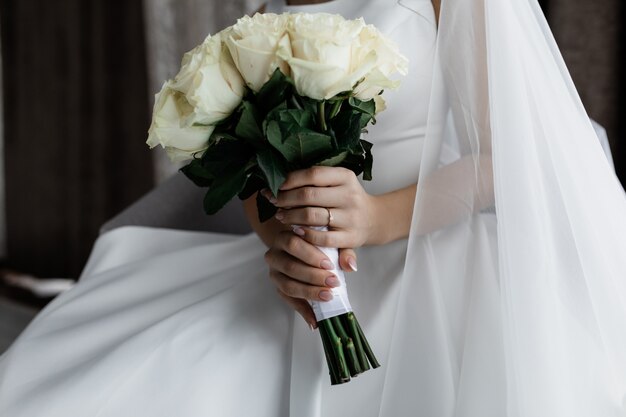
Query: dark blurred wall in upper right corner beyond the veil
542,0,626,184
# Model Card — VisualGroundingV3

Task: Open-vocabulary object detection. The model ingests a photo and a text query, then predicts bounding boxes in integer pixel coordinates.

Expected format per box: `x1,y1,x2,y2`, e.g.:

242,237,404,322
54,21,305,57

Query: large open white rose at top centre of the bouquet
279,13,376,100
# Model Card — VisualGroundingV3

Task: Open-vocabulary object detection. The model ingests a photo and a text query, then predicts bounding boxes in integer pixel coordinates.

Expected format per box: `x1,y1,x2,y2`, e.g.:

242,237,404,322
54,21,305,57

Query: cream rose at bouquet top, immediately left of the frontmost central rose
225,13,291,92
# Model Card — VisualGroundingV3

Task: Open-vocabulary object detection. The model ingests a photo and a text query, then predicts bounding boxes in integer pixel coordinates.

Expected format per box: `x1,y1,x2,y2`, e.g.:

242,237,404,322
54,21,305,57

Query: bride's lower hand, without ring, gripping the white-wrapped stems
265,231,356,327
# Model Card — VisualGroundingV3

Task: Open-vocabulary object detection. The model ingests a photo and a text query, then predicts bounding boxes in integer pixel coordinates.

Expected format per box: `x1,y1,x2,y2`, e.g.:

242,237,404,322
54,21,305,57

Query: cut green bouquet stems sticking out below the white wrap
318,312,380,385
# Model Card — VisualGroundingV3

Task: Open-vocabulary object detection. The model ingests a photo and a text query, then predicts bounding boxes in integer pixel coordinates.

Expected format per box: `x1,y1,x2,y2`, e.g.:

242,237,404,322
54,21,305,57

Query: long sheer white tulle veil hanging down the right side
380,0,626,417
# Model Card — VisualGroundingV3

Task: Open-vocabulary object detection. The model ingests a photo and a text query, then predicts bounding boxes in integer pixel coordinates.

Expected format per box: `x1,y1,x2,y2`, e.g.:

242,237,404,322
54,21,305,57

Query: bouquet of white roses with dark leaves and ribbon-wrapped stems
148,13,407,384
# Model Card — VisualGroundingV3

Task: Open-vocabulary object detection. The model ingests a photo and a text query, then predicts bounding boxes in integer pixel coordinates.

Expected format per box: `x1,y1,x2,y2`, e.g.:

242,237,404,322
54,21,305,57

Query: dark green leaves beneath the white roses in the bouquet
181,69,376,222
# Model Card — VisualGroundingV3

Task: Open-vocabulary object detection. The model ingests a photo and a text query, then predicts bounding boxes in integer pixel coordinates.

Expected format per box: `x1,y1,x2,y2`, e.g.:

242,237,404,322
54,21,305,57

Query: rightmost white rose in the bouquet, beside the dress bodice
354,25,409,100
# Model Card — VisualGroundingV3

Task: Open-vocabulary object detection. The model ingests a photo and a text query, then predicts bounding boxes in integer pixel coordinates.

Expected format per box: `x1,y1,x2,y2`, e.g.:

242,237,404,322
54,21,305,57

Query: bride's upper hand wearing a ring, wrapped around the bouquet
264,166,379,248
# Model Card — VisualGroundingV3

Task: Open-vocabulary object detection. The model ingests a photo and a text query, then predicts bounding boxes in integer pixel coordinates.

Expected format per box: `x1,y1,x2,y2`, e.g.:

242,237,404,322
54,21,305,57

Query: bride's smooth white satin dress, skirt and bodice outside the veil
0,0,436,417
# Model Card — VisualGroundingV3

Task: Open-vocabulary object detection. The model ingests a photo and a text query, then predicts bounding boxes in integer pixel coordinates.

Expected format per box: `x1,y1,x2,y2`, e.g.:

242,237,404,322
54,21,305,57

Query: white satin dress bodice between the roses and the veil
267,0,437,194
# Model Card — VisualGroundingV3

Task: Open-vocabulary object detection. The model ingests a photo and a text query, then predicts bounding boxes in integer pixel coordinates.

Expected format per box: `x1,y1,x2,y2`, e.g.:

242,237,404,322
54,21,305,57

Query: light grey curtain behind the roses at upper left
144,0,264,182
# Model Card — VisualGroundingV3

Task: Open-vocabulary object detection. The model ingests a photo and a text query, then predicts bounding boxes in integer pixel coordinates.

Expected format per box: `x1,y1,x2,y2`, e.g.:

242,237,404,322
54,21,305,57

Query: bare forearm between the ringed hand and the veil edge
367,184,417,245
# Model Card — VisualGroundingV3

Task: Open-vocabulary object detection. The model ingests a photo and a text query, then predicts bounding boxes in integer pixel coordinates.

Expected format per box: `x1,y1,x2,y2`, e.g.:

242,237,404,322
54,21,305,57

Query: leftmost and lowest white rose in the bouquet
147,82,214,162
